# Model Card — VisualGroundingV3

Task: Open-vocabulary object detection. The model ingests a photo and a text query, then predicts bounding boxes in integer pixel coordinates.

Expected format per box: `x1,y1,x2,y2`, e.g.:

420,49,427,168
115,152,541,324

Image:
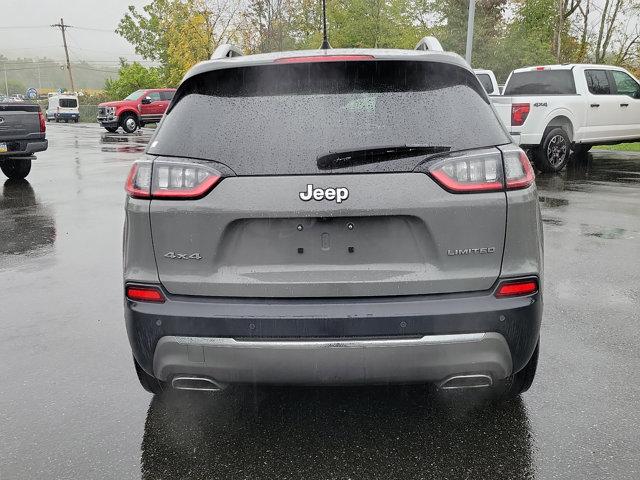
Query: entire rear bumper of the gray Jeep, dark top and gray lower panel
125,284,542,384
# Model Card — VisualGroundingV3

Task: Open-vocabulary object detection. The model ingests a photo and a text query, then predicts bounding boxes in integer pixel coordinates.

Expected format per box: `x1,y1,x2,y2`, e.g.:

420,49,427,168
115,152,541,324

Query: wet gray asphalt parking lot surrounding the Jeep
0,124,640,480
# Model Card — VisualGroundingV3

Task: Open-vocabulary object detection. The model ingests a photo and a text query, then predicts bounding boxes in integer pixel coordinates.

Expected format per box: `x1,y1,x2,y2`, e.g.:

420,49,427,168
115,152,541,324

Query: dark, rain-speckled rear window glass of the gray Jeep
149,61,509,175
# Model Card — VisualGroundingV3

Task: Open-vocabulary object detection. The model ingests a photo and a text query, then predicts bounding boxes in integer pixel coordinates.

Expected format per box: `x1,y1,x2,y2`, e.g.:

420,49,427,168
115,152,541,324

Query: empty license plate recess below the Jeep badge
218,216,429,266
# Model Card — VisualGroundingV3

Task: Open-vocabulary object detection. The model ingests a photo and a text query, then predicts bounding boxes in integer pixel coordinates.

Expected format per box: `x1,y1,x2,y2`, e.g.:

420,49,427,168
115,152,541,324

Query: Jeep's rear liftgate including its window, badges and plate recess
149,61,508,297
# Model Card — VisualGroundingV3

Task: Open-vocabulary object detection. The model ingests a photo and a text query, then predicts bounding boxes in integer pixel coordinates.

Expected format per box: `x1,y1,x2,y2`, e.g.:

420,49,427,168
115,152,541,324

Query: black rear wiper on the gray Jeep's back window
318,145,451,170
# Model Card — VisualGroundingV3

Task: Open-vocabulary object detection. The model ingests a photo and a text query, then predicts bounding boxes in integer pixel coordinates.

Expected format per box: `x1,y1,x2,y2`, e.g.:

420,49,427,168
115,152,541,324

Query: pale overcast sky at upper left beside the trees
0,0,149,63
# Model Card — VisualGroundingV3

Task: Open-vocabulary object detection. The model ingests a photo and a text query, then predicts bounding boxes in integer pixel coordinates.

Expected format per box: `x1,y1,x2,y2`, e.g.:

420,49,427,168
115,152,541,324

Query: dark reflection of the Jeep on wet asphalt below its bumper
142,387,533,480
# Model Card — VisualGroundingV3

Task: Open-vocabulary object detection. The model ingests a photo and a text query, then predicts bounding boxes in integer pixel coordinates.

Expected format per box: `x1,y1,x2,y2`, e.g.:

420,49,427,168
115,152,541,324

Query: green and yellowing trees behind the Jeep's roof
106,0,640,97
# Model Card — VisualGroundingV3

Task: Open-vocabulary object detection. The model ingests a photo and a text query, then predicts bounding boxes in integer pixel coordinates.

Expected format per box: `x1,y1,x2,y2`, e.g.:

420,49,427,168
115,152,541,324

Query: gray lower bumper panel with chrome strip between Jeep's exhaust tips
153,333,512,385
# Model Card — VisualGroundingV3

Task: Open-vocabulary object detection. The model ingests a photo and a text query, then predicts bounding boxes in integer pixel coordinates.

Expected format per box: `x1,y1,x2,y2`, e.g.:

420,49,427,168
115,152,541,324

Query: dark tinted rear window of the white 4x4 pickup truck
504,70,576,95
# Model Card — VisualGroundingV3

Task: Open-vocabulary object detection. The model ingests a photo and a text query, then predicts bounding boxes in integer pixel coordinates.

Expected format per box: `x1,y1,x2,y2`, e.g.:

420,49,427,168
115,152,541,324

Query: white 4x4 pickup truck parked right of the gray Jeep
491,64,640,172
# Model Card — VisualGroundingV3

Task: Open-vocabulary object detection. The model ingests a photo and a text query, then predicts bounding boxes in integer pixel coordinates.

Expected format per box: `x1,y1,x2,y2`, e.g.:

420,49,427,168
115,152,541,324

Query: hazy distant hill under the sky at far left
0,51,118,93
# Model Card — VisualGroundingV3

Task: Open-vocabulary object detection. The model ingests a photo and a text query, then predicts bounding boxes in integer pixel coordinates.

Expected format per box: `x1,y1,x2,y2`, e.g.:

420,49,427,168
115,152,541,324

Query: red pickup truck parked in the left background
97,88,176,133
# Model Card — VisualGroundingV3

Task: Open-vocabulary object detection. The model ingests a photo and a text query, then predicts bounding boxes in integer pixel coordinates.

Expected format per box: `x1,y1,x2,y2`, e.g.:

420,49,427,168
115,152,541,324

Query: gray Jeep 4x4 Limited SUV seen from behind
124,49,542,397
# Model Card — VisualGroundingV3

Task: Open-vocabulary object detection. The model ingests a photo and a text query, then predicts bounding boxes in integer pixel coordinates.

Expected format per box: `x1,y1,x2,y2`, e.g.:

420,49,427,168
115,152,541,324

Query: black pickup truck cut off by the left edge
0,102,48,179
